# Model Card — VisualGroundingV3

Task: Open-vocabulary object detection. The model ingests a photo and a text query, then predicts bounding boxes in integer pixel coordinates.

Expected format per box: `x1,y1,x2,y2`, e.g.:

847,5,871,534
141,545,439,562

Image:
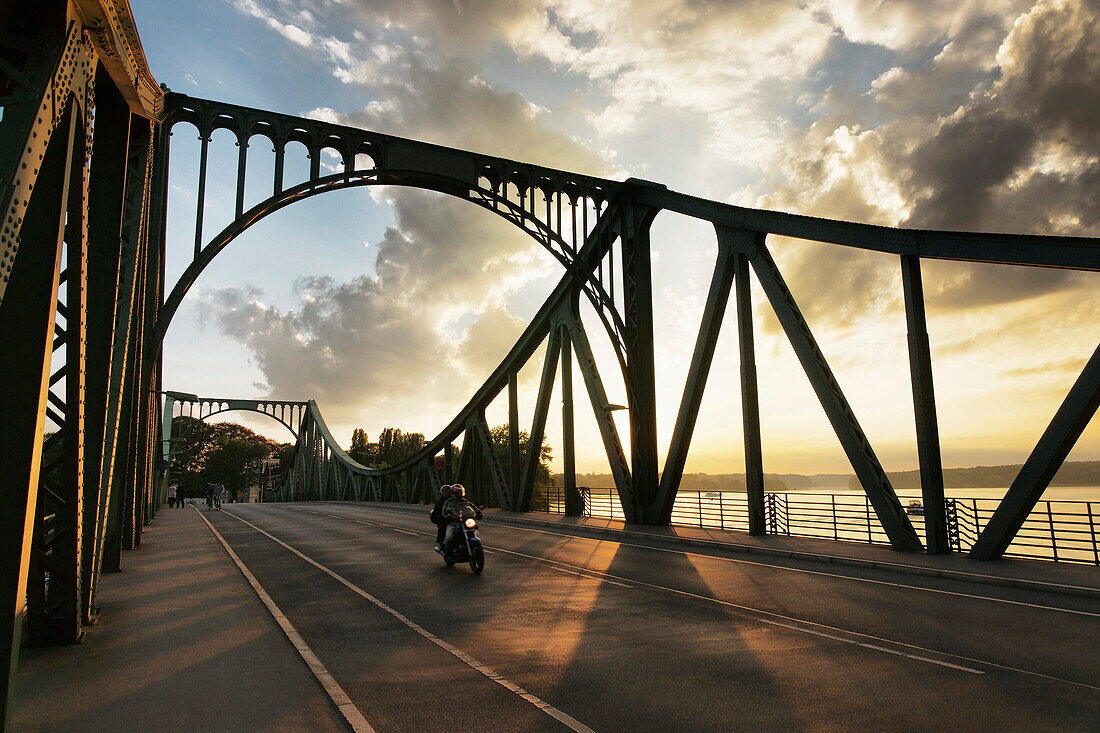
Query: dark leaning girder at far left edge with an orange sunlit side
0,100,75,725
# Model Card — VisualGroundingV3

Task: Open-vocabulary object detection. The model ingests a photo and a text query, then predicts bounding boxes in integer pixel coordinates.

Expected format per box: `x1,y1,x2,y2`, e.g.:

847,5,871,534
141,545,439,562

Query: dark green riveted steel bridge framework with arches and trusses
0,0,1100,714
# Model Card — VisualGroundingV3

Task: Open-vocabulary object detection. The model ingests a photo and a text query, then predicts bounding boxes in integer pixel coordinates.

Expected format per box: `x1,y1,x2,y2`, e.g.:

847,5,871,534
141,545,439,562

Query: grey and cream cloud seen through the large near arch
200,190,550,423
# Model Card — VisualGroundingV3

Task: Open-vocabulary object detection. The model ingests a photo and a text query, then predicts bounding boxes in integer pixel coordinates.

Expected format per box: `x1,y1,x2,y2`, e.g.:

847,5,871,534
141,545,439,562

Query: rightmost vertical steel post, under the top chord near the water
901,254,952,555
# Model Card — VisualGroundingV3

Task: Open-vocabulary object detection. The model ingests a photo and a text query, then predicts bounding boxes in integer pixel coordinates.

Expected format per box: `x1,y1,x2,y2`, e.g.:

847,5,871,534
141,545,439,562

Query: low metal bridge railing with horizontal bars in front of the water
567,486,1100,565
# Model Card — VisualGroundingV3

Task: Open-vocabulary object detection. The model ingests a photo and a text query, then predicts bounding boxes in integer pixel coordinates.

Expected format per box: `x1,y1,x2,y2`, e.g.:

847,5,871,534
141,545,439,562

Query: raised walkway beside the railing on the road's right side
367,503,1100,598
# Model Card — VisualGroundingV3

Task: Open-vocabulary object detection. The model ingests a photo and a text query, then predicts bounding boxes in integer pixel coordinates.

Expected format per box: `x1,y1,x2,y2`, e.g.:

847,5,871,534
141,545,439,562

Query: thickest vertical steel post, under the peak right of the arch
619,200,667,524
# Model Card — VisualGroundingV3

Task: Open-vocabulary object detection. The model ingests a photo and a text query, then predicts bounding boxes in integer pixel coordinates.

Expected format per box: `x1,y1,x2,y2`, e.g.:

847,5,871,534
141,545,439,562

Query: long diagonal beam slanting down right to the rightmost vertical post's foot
747,234,924,553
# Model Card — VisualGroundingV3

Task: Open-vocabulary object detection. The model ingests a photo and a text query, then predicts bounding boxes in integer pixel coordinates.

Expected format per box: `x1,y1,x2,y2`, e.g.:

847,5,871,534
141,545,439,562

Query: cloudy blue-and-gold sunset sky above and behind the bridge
130,0,1100,473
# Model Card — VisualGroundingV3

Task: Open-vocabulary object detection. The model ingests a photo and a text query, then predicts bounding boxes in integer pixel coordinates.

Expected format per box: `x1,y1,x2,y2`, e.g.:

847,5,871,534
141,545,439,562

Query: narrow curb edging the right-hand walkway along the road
363,506,1100,598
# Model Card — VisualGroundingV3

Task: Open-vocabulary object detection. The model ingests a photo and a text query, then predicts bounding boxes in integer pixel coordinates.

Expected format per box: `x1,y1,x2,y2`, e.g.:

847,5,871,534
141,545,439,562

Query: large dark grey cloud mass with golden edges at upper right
758,0,1100,325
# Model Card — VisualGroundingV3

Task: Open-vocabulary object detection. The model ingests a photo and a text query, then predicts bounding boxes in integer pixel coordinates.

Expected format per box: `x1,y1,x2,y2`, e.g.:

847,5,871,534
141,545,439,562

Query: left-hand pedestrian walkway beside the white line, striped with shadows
11,506,347,731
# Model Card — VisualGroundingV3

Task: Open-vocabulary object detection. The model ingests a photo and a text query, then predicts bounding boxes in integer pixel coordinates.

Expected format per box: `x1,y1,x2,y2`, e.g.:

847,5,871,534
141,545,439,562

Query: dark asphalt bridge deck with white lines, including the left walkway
12,503,1100,731
